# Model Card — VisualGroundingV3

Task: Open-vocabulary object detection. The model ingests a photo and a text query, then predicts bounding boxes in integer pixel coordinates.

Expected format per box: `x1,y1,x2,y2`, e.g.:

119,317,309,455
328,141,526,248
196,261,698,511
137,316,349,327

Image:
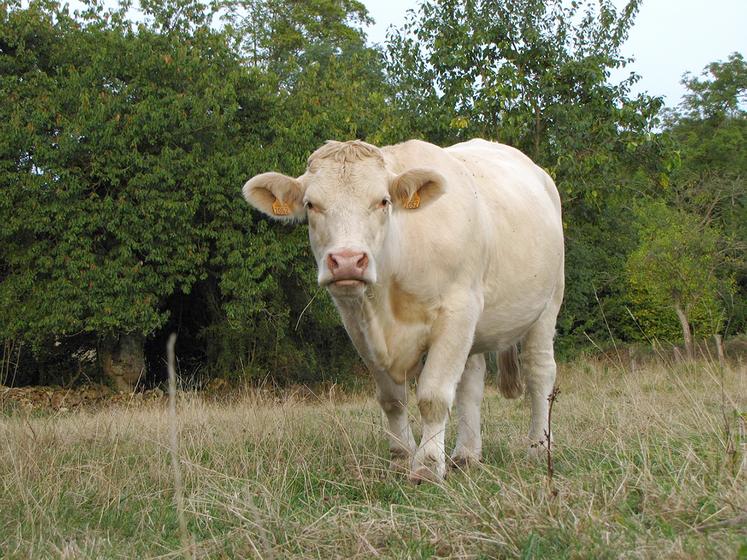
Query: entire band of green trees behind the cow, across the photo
0,0,747,381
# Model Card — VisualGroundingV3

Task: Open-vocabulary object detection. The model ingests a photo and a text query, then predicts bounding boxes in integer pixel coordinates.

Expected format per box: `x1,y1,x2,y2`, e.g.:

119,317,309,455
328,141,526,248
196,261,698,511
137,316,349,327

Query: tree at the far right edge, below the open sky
663,53,747,332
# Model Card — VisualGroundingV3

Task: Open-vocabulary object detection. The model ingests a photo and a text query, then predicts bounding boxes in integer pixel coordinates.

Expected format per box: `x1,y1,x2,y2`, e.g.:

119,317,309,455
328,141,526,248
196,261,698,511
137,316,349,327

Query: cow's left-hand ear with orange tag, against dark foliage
241,173,306,221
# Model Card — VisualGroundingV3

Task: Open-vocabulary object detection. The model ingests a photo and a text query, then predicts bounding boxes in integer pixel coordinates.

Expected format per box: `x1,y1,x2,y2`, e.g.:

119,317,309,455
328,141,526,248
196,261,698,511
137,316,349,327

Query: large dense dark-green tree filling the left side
0,3,280,385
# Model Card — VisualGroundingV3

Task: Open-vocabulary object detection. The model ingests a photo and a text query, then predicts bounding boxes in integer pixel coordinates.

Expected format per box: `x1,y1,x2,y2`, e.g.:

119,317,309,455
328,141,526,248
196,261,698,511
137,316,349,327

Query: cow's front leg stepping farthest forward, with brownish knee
410,302,479,481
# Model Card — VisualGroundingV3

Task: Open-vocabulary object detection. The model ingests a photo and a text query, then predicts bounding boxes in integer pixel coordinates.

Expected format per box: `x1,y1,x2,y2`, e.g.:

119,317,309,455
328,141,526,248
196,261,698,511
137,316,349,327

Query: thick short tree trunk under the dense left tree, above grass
99,333,145,392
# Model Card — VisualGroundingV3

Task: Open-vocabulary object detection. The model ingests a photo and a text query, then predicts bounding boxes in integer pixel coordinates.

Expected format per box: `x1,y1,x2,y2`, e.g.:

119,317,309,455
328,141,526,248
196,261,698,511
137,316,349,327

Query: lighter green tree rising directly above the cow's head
223,0,387,166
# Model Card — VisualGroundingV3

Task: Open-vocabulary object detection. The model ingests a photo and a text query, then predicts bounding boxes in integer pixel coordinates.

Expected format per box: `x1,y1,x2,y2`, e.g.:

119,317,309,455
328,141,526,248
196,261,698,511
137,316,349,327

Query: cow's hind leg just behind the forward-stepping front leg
451,354,485,466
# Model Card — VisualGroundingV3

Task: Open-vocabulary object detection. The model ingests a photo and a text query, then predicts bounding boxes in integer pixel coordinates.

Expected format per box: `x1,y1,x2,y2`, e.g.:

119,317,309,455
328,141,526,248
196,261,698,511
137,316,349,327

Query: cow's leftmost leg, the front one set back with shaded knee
374,372,417,469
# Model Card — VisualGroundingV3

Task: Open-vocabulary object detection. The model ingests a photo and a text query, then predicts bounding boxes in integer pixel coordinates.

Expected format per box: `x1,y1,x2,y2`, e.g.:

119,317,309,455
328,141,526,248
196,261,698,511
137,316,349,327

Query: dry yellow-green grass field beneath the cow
0,356,747,558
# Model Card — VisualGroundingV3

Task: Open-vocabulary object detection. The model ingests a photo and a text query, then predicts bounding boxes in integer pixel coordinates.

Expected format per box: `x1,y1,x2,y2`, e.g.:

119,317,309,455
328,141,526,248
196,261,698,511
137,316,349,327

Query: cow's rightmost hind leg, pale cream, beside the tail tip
521,287,563,458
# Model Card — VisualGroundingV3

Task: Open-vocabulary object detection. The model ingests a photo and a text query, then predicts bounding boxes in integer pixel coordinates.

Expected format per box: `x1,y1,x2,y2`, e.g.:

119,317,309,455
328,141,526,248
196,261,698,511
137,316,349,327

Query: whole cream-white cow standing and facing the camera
243,139,564,481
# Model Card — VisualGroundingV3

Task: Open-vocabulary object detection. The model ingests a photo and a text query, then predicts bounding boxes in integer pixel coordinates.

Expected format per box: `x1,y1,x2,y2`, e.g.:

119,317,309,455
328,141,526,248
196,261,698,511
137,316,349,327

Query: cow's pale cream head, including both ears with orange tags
243,140,445,296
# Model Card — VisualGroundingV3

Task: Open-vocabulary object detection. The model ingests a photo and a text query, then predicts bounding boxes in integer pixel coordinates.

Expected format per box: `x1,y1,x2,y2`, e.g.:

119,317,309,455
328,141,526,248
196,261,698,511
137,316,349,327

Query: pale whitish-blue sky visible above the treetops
362,0,747,107
